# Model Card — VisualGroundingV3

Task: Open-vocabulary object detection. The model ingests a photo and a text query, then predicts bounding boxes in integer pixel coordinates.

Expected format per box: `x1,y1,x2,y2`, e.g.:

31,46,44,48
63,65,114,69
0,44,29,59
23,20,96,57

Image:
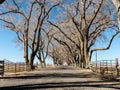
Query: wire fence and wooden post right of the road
92,59,120,76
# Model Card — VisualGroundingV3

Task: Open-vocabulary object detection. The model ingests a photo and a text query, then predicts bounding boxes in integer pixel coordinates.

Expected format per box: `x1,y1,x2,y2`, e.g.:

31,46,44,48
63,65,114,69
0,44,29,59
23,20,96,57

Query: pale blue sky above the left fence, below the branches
0,28,24,62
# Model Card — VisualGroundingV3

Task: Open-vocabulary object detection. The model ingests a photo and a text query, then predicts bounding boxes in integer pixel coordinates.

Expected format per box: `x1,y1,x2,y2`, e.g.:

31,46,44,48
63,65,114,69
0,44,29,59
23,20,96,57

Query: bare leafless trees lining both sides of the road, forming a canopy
0,0,119,70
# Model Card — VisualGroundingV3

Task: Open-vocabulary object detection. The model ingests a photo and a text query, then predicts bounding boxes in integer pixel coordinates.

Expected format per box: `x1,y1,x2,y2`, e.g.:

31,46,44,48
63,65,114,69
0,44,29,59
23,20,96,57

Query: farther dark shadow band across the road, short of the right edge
0,73,96,79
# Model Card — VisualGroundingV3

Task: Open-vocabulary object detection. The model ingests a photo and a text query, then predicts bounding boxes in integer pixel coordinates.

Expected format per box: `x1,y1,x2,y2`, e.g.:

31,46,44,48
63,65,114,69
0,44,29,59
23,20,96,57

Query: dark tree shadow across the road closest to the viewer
0,81,120,90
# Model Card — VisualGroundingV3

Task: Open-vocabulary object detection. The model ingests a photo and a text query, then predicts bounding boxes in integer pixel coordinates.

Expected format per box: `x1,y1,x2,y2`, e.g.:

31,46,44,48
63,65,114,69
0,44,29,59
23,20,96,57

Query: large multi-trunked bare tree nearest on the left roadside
0,0,59,70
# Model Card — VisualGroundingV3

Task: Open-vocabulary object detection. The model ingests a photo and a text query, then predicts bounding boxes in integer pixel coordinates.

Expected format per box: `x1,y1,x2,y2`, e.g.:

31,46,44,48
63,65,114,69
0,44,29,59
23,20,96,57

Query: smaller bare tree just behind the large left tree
36,29,52,68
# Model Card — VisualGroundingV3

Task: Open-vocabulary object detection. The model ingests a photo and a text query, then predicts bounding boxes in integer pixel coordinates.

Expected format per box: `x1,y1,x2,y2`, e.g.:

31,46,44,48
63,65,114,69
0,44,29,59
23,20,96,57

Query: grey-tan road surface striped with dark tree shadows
0,66,120,90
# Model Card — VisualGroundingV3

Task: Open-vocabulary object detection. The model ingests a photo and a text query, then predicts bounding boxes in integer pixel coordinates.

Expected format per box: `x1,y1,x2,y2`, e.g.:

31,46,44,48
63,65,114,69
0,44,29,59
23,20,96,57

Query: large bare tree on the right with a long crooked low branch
48,0,119,67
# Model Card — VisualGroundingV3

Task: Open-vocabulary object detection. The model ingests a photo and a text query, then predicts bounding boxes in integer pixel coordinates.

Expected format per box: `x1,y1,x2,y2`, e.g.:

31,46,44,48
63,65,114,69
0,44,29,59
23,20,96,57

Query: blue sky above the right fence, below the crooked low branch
92,35,120,61
